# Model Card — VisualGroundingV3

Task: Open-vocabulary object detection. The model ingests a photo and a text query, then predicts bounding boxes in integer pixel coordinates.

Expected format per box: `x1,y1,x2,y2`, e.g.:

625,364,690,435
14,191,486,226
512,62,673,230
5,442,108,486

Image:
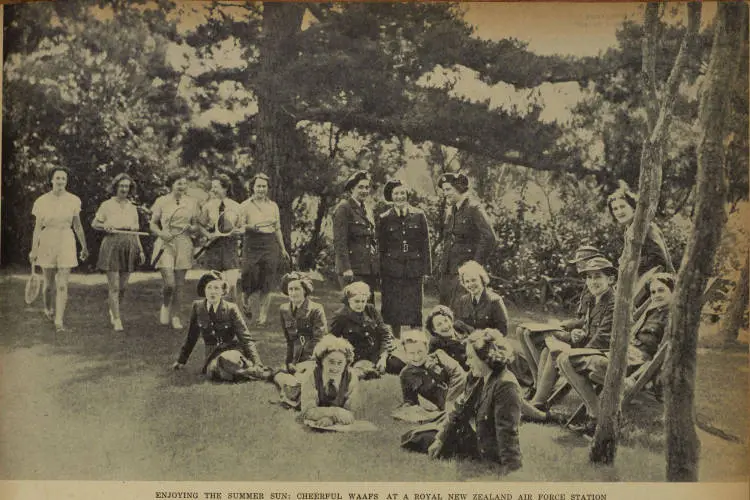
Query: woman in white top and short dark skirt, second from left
91,173,146,332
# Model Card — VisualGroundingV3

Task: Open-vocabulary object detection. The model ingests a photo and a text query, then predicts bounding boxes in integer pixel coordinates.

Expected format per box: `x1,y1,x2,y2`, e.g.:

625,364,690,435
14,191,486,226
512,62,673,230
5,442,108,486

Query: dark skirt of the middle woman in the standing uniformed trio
380,276,424,327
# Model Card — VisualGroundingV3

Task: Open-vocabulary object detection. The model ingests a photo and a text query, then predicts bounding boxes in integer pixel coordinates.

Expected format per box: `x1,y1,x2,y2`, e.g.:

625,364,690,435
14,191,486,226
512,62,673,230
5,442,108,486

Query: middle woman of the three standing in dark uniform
377,180,432,338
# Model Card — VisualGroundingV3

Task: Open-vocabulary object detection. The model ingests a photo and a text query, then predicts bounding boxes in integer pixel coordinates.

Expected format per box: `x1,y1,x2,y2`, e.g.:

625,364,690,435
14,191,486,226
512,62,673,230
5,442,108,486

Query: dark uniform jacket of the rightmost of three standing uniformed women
440,198,497,274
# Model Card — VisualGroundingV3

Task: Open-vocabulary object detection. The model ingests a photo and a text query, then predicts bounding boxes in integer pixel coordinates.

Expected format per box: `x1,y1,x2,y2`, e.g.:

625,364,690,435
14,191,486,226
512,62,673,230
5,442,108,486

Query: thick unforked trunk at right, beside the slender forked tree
664,2,747,481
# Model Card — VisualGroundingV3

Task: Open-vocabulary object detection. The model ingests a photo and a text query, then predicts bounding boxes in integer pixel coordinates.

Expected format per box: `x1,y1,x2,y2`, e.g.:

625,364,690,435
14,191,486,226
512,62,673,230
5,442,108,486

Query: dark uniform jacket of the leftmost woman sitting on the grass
177,299,261,372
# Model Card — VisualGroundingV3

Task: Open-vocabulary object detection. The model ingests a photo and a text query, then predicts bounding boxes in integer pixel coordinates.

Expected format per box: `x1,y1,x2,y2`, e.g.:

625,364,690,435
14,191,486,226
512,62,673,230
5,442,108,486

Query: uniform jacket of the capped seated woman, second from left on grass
279,299,327,364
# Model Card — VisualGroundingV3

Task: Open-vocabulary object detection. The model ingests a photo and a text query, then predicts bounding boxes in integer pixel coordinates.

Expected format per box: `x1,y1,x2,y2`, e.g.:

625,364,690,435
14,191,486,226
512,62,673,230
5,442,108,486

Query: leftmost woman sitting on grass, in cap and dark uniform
172,271,270,381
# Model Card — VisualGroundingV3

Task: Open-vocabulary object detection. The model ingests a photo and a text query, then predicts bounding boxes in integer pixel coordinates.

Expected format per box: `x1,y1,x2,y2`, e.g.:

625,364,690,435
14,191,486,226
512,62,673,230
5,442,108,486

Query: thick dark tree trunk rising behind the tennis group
255,2,305,249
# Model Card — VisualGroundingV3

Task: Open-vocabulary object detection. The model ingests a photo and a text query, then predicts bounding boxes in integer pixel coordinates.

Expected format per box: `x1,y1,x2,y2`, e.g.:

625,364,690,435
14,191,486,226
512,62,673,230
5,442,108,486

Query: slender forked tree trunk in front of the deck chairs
589,2,701,464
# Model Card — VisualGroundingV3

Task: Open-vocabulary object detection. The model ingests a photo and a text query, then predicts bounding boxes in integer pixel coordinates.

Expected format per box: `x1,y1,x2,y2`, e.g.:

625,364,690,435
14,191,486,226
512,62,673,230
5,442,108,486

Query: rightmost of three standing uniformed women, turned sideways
438,174,497,308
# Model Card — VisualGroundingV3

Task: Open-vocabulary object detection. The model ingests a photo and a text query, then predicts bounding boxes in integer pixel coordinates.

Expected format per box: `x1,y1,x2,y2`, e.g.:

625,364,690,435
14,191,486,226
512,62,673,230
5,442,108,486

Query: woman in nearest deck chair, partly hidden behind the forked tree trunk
557,273,675,431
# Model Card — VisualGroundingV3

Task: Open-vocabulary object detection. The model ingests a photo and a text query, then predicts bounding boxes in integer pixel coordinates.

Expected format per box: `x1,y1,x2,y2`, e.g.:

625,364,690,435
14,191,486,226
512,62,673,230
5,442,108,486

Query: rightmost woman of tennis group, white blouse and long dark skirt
240,174,289,326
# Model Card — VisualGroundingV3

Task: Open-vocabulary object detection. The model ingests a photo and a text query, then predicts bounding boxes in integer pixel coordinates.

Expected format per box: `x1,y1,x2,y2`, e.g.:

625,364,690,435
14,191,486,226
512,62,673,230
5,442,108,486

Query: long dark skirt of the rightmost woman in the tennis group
242,233,281,294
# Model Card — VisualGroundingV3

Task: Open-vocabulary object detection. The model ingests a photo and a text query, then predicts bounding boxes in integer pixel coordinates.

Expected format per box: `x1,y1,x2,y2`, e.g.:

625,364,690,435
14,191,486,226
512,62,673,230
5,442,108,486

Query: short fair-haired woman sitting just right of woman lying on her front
399,330,466,411
